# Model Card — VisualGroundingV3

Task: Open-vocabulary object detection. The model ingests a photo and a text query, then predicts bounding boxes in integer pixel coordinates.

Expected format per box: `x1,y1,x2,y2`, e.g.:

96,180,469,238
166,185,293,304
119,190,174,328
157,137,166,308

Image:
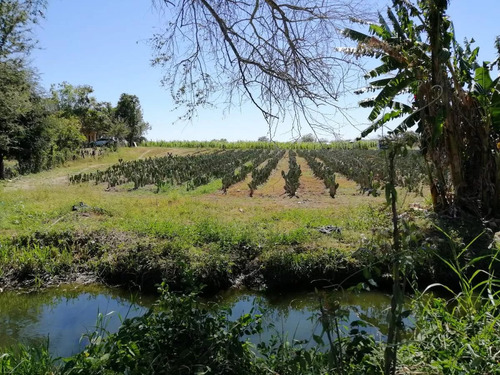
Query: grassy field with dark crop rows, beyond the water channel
0,147,426,291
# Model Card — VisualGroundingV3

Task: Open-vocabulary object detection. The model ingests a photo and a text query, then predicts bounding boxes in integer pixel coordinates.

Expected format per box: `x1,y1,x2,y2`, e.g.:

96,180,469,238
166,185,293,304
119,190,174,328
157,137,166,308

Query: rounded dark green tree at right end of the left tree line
115,94,150,146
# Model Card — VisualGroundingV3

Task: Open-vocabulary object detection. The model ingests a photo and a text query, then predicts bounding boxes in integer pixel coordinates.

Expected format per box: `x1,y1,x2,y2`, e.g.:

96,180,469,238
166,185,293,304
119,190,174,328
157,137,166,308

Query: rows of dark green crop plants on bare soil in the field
66,149,427,198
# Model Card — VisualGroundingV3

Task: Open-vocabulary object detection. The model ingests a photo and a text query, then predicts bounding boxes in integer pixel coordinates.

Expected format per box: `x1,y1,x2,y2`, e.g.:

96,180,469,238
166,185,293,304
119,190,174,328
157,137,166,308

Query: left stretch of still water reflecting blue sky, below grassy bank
0,285,151,357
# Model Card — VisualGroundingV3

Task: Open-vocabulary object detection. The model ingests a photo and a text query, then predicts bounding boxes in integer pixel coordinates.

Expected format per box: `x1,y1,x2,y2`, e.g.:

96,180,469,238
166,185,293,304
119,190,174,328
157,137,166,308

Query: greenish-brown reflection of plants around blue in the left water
0,285,150,347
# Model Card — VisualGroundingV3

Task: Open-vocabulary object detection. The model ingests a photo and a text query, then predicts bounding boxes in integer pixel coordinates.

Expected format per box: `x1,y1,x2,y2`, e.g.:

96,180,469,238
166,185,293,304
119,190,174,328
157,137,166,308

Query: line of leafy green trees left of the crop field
0,0,149,179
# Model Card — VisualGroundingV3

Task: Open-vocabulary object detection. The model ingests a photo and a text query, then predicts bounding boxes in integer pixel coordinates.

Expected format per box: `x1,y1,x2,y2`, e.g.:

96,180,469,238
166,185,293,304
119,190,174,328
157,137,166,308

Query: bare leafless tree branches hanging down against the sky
151,0,376,136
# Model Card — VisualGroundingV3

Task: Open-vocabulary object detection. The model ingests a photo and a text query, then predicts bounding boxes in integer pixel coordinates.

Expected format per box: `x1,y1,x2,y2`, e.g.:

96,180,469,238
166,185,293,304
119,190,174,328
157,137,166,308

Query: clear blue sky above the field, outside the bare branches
32,0,500,141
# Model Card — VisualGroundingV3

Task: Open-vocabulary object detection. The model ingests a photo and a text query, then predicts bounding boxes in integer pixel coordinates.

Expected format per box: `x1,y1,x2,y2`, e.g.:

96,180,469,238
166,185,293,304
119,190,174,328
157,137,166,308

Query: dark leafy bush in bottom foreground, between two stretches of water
64,288,262,375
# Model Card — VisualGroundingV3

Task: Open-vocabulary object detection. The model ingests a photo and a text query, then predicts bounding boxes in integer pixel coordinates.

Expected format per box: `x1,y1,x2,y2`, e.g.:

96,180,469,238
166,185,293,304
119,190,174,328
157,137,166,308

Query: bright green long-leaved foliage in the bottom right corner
401,235,500,375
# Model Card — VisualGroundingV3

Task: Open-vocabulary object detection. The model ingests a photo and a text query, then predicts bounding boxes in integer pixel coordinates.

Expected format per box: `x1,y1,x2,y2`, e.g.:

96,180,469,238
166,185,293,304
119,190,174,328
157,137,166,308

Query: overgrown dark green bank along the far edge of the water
0,230,444,294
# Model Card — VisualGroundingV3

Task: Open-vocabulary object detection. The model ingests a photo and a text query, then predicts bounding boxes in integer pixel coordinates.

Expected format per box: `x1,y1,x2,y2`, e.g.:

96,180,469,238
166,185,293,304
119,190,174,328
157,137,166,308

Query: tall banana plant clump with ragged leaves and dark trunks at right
345,0,500,218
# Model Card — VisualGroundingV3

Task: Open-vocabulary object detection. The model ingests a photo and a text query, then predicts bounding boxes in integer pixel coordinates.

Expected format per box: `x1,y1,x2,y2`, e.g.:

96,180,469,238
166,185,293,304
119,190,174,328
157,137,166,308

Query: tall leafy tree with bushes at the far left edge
0,4,93,179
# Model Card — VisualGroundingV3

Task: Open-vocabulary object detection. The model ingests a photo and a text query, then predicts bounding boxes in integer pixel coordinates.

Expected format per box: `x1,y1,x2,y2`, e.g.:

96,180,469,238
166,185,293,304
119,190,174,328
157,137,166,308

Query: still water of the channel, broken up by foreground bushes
0,285,398,357
